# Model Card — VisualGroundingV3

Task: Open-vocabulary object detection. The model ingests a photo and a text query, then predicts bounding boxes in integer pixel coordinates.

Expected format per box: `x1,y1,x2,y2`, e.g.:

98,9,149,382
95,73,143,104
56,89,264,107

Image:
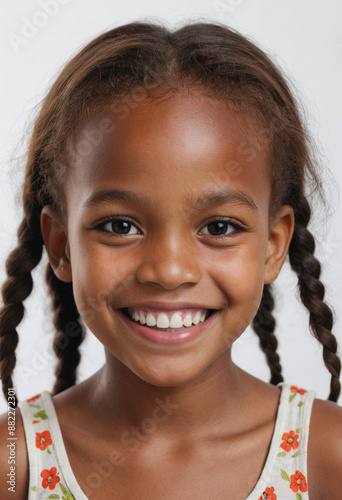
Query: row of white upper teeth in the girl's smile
130,310,211,330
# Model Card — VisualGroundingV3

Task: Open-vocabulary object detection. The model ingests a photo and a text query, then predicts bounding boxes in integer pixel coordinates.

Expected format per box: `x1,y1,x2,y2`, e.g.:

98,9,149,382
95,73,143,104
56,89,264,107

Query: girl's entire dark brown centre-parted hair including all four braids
0,22,340,401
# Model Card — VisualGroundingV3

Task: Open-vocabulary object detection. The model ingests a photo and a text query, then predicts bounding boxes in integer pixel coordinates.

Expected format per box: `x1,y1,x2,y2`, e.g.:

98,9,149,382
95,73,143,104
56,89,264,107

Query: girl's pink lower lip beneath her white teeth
118,311,218,346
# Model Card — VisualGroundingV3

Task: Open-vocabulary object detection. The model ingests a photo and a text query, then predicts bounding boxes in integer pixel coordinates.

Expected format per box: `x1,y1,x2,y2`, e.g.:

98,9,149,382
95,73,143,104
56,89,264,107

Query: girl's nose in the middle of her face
136,234,202,290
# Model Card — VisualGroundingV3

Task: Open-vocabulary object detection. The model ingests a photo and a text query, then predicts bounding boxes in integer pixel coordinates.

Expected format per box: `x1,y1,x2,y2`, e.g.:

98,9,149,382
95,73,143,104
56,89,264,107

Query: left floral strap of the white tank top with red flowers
19,391,87,500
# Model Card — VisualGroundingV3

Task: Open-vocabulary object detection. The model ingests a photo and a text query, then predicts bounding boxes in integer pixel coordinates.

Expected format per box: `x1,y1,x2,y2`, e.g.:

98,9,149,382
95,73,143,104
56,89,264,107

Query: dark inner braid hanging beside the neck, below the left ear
46,264,84,394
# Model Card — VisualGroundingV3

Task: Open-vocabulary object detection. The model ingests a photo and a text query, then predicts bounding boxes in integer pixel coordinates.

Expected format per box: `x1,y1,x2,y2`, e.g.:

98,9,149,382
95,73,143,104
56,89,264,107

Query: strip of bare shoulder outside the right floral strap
308,399,342,500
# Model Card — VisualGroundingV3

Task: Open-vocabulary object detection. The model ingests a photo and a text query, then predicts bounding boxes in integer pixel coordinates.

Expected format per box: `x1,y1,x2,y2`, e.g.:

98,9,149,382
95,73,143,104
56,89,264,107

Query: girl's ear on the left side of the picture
40,205,72,283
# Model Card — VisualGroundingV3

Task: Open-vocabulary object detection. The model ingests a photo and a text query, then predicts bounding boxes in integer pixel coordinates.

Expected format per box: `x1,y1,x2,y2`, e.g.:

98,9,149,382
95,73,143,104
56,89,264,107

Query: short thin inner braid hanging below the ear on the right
252,285,284,385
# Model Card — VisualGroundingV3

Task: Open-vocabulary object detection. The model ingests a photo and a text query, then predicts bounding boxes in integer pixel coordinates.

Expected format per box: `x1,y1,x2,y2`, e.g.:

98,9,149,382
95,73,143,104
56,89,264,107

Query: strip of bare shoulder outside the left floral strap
0,408,29,500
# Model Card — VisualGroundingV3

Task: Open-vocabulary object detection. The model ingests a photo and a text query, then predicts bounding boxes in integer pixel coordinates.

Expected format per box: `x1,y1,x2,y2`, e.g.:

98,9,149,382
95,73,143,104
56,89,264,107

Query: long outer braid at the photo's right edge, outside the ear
289,195,341,401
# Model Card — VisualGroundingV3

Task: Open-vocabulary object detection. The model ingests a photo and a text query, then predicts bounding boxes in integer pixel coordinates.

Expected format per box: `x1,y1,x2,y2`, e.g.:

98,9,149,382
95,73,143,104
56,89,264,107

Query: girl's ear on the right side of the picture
264,205,294,284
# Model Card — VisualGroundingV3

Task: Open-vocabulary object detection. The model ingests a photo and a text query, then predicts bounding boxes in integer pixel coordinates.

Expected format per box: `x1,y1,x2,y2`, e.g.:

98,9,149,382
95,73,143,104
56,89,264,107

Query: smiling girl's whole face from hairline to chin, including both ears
42,91,293,386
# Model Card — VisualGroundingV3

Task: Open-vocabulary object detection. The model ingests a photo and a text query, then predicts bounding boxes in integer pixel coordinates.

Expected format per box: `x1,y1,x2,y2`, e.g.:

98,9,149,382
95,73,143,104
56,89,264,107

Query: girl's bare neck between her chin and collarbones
88,352,245,440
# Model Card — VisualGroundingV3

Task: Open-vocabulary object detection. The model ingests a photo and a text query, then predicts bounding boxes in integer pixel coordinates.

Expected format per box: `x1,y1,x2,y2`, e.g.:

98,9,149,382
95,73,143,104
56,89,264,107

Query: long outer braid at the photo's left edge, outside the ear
0,211,43,406
